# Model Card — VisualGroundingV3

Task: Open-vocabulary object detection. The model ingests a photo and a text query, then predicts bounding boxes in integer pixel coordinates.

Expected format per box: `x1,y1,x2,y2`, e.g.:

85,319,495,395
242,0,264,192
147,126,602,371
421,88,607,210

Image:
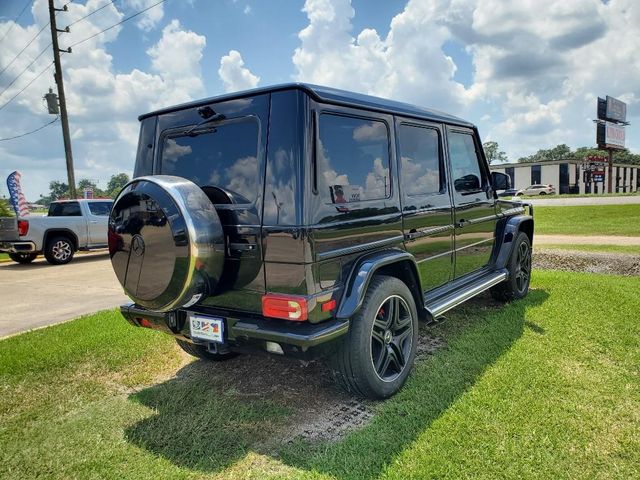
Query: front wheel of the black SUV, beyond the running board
491,232,531,302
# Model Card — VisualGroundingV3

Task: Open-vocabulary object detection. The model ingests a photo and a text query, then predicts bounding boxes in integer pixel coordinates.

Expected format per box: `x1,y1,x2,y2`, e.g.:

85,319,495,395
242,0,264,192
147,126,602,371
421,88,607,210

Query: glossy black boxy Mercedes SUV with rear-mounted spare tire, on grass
109,84,533,398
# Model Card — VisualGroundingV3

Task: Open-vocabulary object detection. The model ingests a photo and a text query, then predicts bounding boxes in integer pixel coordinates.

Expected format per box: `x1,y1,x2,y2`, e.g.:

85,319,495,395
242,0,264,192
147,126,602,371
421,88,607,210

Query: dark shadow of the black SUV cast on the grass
125,290,548,478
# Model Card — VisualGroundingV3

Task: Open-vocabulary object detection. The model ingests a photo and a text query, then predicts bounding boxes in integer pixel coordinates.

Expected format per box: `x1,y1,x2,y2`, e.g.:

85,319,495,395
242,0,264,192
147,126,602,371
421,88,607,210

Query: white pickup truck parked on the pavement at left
0,199,113,265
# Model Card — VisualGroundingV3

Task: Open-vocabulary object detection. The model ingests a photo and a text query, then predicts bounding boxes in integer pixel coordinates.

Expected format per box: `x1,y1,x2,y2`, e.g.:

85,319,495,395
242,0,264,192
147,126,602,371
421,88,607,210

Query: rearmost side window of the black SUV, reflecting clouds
316,114,391,203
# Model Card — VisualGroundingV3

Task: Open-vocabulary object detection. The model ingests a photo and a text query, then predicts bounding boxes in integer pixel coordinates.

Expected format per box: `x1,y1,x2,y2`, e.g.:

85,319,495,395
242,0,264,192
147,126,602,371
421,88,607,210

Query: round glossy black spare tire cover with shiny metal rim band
108,175,225,312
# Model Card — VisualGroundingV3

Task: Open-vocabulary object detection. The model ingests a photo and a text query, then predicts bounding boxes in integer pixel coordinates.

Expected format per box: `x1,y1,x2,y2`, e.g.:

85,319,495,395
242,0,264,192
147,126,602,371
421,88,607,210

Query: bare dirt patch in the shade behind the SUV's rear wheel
170,325,445,446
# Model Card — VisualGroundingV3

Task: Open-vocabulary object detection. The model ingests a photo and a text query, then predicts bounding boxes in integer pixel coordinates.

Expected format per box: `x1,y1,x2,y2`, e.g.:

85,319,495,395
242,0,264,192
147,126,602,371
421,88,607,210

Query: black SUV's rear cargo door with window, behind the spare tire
155,94,270,311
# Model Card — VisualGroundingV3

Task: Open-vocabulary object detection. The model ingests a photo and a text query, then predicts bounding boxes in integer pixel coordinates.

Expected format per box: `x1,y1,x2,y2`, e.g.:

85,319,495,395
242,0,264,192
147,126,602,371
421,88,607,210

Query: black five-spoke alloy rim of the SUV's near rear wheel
371,295,413,382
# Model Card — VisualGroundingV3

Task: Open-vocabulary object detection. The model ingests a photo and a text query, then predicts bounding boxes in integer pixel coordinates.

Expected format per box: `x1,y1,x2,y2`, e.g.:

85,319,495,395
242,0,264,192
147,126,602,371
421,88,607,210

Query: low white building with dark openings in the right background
491,160,640,193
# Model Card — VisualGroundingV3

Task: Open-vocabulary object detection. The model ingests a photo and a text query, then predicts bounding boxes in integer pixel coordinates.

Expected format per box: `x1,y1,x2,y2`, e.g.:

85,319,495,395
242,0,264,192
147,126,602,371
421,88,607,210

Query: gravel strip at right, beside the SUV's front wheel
533,247,640,276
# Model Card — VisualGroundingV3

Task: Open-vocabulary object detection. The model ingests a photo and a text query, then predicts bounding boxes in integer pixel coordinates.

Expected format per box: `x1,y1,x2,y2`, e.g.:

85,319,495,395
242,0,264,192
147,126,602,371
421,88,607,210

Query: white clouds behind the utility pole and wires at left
0,0,206,200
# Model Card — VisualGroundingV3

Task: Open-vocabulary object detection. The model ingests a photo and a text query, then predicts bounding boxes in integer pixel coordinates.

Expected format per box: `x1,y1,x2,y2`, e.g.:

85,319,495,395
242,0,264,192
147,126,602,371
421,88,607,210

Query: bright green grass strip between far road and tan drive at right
533,205,640,236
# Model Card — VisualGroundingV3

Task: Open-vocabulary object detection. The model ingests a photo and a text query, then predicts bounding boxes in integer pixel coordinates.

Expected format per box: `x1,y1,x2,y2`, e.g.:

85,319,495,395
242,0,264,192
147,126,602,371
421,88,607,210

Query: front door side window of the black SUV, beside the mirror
449,132,486,195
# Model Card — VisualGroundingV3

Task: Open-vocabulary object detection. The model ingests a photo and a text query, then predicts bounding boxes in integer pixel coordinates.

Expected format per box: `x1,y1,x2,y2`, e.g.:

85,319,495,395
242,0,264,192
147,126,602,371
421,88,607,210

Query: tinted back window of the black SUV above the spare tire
160,118,259,203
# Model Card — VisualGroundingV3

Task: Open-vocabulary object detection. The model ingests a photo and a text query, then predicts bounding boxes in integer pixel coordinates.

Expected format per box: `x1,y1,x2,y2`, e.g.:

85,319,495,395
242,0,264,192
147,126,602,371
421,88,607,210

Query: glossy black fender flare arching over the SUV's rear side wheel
336,248,424,318
